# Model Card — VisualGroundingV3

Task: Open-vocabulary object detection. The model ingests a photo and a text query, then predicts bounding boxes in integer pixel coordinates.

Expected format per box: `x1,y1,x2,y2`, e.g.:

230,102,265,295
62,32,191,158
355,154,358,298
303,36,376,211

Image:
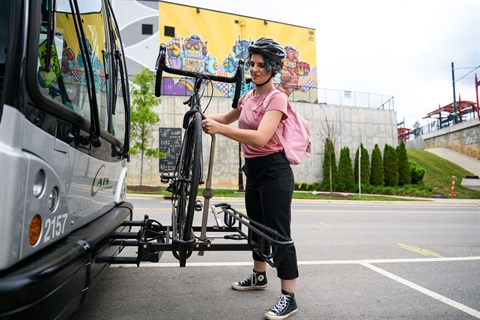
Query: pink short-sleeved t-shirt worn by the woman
238,89,288,158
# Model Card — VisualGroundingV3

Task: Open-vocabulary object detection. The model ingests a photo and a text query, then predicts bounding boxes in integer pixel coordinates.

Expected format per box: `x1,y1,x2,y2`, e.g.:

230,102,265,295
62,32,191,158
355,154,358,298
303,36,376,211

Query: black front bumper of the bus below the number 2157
0,203,133,319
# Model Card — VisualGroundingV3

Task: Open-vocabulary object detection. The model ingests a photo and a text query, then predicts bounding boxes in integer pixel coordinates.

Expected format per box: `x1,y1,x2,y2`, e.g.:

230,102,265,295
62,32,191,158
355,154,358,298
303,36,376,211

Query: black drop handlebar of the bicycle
155,44,245,109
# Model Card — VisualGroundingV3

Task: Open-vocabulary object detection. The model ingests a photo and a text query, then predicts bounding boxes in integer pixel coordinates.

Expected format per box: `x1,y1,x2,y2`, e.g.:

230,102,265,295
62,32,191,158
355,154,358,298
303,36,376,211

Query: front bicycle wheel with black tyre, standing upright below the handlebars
172,112,202,267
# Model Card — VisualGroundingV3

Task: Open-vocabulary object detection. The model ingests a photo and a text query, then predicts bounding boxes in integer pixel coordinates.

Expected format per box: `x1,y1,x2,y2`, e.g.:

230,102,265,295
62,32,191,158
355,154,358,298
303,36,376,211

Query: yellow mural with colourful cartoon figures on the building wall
159,2,317,102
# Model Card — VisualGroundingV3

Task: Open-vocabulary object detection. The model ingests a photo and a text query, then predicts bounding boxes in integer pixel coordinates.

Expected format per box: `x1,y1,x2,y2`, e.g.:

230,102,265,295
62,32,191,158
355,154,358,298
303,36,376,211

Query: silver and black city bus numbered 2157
0,0,132,319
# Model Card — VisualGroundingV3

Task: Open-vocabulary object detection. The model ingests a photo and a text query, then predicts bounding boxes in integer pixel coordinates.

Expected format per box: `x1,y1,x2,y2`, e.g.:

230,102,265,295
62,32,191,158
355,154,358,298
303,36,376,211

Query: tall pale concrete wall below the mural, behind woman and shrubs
128,96,398,188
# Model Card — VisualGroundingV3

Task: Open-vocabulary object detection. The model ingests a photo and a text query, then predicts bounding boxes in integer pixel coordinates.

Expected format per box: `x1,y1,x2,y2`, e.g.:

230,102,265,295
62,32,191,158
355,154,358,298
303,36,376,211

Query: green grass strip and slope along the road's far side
128,149,480,201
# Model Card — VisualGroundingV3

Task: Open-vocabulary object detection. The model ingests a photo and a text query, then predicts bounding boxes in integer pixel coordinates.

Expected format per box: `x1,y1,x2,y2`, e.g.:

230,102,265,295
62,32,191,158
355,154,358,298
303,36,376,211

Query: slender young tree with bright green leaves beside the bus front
130,67,165,185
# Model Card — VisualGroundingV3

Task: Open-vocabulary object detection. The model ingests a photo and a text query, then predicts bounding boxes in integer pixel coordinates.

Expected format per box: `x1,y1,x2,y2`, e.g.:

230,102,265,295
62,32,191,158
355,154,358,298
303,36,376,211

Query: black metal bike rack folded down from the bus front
109,203,293,268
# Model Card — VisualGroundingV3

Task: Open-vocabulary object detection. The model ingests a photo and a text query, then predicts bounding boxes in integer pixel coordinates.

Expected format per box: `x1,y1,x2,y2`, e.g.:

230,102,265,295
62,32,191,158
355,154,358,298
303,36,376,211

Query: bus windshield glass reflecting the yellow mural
38,0,108,130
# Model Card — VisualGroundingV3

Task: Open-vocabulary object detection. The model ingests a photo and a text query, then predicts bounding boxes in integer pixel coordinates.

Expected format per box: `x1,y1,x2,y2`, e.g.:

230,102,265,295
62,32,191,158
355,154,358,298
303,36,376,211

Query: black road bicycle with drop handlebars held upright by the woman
155,44,244,267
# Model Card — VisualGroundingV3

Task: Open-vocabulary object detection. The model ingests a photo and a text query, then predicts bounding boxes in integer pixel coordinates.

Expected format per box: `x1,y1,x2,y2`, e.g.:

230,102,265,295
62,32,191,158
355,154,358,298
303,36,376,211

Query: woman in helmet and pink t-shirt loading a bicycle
203,37,298,319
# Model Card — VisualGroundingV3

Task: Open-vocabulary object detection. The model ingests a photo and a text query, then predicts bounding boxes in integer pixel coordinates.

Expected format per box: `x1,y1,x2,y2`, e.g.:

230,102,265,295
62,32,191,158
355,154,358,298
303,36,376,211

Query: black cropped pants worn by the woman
243,153,298,280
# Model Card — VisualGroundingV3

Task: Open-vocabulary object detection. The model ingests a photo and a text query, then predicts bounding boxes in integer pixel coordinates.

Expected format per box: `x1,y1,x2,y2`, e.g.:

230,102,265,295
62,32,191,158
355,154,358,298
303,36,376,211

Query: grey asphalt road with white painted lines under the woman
71,199,480,320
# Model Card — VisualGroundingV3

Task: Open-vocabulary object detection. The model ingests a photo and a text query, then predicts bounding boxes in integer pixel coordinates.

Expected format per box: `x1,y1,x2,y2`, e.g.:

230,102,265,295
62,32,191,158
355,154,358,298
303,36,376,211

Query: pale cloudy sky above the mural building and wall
163,0,480,128
